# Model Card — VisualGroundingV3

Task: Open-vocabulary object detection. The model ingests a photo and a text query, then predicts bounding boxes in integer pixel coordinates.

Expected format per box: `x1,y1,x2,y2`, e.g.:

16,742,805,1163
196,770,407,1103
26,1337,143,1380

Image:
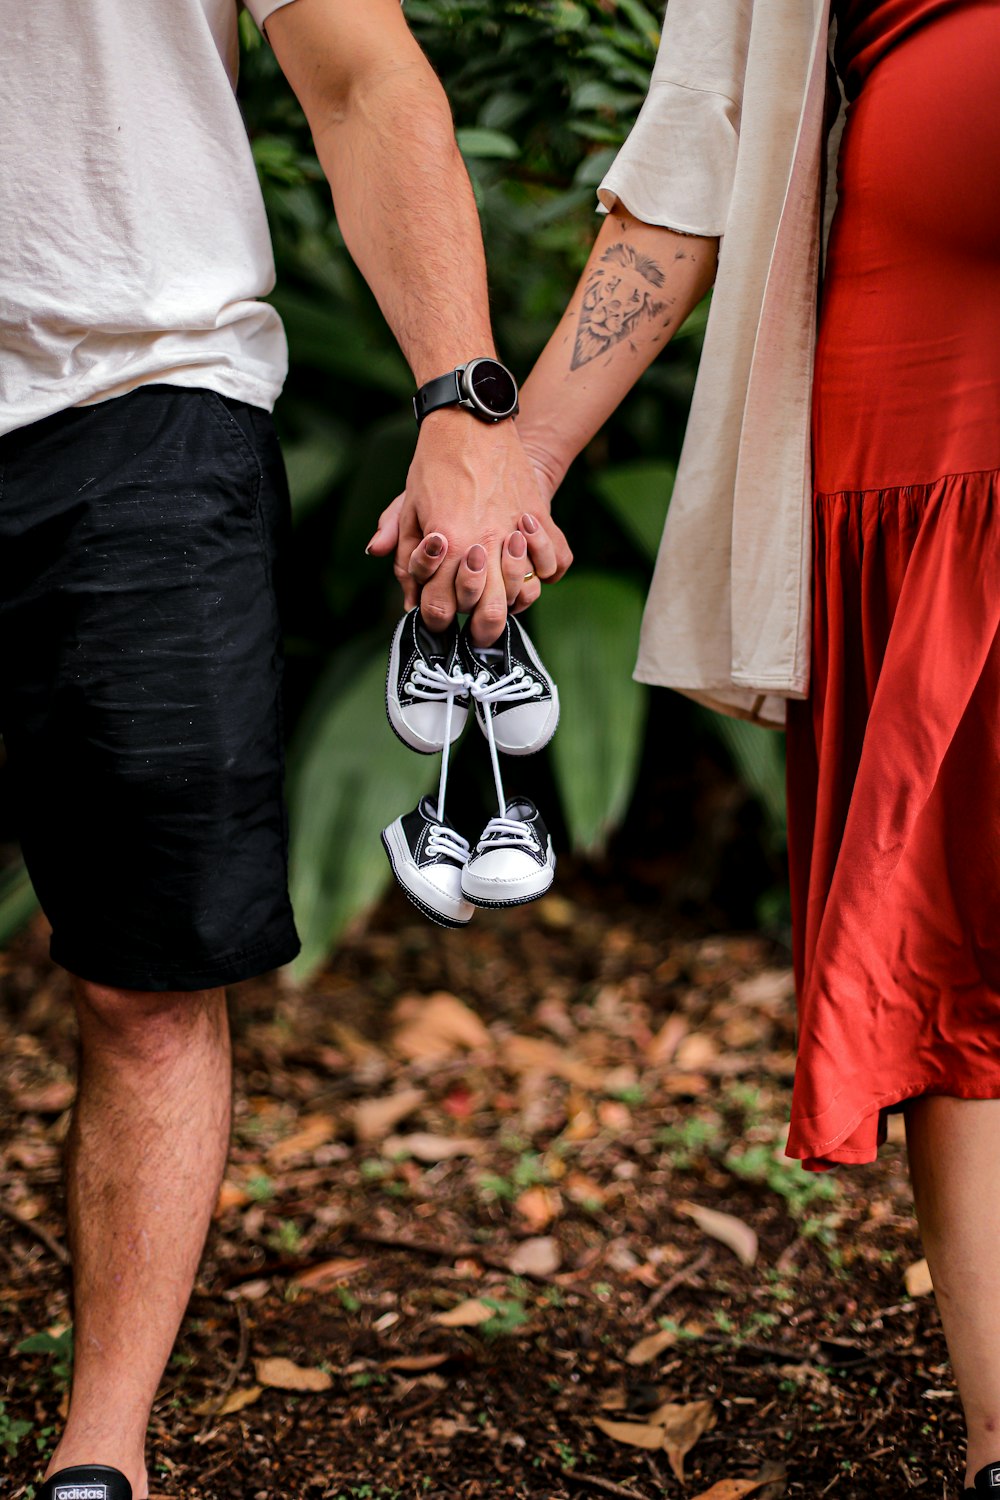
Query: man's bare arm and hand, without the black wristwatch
267,0,568,642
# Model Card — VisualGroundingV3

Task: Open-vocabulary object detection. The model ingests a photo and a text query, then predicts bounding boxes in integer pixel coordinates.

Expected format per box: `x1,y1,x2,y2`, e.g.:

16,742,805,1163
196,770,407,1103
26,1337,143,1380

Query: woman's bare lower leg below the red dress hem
907,1098,1000,1484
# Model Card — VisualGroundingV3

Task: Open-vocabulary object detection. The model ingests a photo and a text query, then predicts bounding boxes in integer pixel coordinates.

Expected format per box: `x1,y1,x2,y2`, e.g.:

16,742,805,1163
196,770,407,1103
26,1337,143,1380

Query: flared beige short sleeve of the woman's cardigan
597,0,753,237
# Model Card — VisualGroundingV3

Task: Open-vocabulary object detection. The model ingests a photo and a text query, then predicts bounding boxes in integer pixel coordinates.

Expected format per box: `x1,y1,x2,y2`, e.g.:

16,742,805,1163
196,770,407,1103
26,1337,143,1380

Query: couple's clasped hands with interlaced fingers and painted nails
367,410,573,645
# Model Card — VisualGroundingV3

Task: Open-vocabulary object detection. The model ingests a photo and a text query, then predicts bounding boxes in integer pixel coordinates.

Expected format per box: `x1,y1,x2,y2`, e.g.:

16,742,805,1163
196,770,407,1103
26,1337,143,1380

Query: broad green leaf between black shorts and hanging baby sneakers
288,635,438,978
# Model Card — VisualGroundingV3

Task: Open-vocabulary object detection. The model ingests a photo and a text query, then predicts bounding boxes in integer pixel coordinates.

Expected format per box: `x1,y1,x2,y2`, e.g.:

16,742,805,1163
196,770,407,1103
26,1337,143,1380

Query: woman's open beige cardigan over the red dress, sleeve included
600,0,840,726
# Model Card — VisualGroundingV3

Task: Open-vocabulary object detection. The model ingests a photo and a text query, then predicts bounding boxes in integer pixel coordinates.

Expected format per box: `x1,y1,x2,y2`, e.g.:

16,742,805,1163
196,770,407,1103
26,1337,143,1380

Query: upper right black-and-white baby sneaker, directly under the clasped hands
459,615,559,755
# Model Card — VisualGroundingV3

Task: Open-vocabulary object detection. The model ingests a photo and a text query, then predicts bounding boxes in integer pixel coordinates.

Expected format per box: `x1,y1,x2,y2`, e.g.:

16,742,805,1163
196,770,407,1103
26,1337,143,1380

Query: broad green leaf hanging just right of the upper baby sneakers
532,573,648,855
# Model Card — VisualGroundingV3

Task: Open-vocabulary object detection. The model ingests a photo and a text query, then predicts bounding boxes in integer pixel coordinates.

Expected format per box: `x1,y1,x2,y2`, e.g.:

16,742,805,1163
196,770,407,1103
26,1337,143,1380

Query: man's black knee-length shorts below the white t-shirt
0,386,298,990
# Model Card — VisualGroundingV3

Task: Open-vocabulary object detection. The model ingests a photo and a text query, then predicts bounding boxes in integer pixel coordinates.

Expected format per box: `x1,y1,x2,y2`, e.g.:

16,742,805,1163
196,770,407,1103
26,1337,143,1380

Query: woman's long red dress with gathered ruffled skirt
789,0,1000,1170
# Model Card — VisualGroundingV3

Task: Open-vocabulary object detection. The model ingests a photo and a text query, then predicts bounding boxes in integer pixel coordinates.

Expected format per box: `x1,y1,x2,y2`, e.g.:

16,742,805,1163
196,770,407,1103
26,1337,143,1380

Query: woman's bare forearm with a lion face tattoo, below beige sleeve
517,204,718,513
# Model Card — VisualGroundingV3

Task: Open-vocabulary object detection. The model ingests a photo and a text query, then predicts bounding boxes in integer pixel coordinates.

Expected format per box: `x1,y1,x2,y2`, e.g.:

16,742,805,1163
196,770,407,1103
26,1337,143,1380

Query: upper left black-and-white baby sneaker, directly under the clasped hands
385,608,469,755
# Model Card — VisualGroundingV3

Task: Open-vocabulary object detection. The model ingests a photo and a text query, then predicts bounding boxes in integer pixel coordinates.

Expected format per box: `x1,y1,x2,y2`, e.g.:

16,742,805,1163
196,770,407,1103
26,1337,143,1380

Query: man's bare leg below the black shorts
48,981,231,1500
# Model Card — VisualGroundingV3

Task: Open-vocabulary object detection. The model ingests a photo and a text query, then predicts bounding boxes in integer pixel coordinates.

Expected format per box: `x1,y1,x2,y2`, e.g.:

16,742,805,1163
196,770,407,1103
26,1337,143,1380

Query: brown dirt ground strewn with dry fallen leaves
0,875,961,1500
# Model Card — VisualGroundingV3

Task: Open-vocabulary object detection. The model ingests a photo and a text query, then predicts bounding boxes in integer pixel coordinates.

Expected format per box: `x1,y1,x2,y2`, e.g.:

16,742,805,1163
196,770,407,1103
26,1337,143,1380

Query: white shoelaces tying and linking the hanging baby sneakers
406,662,543,863
